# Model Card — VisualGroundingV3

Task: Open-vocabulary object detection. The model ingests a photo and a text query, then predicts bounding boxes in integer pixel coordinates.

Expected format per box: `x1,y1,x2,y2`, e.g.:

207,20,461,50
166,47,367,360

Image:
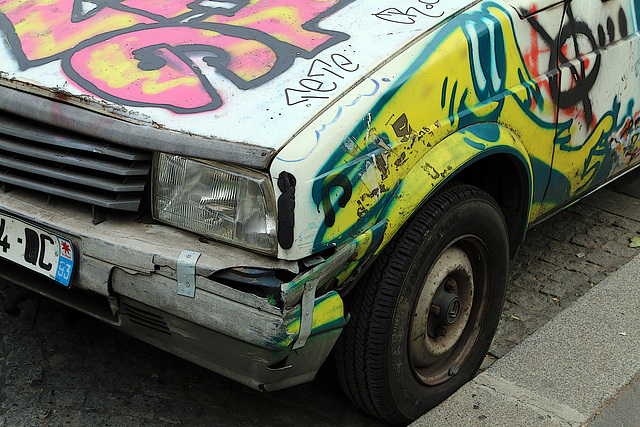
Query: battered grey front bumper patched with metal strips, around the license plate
0,190,345,390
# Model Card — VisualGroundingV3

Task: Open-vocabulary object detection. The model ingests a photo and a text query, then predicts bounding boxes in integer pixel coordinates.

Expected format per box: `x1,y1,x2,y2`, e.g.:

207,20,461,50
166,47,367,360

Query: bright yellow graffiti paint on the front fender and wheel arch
322,4,555,251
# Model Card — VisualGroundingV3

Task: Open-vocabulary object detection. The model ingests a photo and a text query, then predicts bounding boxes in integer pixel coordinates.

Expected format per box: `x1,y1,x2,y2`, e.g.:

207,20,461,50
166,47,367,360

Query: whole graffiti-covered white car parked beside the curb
0,0,640,423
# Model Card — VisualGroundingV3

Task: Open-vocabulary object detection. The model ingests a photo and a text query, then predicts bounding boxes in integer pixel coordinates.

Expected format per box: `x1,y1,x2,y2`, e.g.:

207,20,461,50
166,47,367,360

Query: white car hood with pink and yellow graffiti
0,0,471,160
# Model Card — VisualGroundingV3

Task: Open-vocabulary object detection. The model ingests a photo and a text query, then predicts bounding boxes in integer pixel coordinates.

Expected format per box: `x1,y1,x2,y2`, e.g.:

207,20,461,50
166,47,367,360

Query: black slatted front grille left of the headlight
0,112,151,211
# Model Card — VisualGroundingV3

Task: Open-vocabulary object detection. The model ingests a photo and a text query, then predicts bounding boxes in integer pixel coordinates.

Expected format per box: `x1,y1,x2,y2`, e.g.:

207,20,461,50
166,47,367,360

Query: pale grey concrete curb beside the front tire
411,252,640,427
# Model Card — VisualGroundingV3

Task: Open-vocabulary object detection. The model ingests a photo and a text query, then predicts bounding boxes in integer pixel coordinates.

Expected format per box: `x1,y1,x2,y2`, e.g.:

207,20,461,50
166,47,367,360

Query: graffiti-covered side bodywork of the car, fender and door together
271,2,638,259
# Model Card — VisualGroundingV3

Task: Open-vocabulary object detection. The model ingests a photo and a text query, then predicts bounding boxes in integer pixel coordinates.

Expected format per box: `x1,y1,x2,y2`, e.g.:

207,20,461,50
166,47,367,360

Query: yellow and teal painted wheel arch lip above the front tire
378,123,533,256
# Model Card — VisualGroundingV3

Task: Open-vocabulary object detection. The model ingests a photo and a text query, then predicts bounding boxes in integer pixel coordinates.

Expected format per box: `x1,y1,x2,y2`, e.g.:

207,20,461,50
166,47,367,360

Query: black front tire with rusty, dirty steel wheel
334,185,509,424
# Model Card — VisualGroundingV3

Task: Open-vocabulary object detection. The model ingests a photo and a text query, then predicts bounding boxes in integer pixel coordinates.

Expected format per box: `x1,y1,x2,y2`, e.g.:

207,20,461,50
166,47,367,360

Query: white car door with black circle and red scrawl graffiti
545,0,640,206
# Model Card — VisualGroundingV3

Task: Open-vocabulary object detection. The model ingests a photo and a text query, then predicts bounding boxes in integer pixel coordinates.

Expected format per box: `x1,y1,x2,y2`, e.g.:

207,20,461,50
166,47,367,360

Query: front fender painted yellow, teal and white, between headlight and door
271,3,561,259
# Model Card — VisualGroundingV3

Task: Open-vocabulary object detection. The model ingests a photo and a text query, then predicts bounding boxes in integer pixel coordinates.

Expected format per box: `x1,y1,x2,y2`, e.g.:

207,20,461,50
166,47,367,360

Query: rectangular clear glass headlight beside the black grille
152,153,276,254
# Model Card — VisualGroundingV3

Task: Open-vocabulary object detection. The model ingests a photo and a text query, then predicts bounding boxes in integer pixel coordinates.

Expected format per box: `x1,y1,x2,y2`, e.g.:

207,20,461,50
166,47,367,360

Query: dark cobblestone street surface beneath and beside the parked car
0,172,640,427
